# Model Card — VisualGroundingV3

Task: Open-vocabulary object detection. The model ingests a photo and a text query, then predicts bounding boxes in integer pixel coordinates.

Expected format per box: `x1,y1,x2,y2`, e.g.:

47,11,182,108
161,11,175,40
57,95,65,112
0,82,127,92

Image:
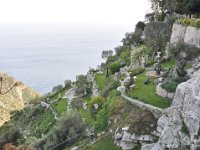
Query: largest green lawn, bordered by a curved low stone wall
127,73,170,108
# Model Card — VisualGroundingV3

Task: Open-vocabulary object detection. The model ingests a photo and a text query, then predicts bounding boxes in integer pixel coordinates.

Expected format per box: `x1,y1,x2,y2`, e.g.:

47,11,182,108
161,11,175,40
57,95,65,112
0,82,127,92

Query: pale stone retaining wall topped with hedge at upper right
170,23,200,48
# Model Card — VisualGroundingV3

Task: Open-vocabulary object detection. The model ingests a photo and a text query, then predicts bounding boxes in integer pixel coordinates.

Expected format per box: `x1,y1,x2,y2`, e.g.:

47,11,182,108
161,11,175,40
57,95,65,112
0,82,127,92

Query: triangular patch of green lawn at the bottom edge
86,135,120,150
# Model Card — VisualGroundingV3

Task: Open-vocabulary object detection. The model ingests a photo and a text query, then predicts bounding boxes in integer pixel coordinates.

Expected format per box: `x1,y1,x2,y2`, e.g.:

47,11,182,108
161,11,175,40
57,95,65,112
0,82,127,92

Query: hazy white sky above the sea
0,0,149,24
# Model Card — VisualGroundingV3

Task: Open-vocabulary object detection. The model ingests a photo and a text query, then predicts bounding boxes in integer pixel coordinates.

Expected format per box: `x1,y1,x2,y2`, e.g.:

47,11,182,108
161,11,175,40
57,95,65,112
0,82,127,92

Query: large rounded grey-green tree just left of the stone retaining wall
144,22,171,59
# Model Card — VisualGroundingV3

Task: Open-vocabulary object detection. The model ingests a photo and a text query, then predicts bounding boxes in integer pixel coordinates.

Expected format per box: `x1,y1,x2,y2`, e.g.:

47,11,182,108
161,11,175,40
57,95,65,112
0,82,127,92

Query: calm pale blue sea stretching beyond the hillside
0,24,131,94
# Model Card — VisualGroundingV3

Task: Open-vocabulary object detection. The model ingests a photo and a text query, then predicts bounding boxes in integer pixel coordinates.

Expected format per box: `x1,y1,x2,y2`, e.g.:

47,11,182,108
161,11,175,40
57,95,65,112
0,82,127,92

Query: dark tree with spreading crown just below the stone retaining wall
169,42,200,77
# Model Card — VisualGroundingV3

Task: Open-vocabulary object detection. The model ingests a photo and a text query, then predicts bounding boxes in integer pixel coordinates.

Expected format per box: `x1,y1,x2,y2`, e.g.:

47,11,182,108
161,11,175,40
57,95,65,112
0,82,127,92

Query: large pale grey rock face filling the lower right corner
142,67,200,150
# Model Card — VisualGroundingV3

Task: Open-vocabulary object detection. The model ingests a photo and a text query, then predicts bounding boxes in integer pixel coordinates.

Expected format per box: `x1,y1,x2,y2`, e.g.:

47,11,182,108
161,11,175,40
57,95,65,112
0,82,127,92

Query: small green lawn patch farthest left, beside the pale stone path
53,98,68,116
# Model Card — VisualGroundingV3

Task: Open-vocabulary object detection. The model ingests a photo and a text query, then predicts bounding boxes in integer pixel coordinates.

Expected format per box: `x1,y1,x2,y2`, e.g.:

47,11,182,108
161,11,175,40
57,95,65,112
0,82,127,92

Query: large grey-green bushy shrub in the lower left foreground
33,112,85,150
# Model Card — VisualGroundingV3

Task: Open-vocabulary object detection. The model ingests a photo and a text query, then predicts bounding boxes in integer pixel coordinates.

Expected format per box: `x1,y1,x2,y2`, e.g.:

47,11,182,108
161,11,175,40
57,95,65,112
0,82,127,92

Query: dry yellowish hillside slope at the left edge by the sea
0,73,41,126
